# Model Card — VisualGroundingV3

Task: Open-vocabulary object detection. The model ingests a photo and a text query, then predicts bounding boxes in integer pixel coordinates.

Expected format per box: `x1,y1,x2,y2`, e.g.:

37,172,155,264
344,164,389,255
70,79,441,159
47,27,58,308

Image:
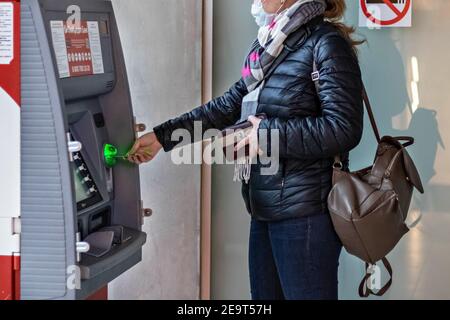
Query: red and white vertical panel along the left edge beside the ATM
0,0,20,300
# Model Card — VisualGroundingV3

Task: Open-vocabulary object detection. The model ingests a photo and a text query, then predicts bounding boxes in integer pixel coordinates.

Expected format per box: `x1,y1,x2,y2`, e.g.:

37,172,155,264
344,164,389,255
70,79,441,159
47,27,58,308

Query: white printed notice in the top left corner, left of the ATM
0,2,14,65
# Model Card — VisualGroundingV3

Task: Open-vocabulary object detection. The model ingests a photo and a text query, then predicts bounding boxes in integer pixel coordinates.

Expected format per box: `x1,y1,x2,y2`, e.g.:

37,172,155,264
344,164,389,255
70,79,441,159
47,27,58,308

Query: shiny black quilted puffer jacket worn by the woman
154,21,364,221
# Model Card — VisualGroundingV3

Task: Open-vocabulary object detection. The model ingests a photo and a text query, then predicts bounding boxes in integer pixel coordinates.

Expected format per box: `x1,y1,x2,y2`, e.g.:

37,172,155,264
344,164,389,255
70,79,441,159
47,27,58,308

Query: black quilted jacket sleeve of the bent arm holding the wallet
259,33,364,159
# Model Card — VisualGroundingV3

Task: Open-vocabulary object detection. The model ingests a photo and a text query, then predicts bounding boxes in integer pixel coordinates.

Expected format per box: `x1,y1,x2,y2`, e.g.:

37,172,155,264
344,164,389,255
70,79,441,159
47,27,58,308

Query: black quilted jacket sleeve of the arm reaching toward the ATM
153,79,248,151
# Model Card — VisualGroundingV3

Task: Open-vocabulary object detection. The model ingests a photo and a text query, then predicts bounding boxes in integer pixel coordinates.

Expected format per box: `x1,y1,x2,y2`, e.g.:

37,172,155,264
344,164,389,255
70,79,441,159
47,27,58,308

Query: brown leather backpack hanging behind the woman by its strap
328,89,424,297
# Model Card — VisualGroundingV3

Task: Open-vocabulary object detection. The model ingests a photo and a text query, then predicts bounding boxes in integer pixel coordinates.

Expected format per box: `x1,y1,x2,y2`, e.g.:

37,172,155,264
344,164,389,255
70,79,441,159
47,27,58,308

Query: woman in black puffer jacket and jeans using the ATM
130,0,363,300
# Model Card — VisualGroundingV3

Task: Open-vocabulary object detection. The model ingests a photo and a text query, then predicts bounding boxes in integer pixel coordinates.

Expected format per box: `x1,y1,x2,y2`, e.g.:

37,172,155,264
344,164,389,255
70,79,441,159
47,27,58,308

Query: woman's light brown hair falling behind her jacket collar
325,0,365,53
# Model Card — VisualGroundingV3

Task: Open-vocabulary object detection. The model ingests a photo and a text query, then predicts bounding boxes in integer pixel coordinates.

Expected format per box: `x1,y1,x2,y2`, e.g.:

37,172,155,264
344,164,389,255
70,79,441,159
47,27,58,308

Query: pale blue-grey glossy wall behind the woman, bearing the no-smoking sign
212,0,450,299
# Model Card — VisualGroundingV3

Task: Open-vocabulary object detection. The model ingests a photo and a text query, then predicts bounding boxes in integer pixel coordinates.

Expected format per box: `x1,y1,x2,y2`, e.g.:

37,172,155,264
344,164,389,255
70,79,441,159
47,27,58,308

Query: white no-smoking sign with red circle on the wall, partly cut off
359,0,412,29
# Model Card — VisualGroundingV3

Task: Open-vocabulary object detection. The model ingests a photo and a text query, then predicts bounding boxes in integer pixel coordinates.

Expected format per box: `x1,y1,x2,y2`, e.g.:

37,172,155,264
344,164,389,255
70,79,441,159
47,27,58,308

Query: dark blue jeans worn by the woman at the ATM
249,214,342,300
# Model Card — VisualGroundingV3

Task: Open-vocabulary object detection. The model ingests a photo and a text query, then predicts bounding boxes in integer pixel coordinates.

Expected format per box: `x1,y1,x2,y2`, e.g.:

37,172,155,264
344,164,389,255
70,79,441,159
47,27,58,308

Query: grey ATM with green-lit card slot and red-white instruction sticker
20,0,151,300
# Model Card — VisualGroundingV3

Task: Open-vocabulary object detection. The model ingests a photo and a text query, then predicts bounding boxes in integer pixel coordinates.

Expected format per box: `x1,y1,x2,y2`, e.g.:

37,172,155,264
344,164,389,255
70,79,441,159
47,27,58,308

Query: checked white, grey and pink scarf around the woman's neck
234,0,326,182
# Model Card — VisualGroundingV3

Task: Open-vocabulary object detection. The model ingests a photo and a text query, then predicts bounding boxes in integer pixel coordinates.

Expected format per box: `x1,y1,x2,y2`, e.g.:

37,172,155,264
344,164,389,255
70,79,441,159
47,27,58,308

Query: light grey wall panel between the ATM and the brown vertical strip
110,0,202,299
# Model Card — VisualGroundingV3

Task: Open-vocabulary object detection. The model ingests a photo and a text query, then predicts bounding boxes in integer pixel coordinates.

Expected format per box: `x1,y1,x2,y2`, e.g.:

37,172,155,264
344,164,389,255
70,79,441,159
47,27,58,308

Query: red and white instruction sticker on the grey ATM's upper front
50,21,105,78
